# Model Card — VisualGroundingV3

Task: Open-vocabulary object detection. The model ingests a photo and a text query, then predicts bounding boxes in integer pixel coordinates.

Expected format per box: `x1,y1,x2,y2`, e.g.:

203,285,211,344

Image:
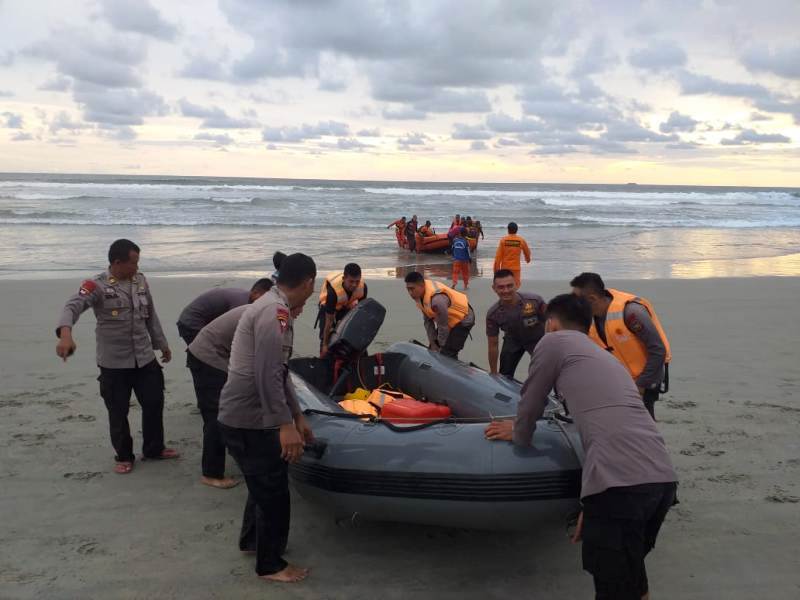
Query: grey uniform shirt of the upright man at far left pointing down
56,271,169,369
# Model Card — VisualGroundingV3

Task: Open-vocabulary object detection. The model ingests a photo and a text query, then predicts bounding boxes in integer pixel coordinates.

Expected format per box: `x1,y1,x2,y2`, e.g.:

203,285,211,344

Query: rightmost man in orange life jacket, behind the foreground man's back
570,273,672,419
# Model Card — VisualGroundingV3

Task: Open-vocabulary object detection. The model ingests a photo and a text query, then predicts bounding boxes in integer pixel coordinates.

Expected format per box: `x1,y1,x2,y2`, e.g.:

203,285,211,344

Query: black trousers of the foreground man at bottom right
581,483,677,600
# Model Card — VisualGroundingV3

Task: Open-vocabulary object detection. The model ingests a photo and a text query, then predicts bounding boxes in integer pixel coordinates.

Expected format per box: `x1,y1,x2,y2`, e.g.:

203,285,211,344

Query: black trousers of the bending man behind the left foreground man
186,352,228,479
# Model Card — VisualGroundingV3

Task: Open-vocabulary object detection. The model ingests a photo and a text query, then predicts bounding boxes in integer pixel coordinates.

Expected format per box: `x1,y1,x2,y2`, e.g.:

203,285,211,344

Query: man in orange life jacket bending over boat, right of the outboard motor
406,271,475,359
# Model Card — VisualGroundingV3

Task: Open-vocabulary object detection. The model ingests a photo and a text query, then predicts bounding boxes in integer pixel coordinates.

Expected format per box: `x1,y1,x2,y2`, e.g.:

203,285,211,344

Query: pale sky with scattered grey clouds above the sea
0,0,800,186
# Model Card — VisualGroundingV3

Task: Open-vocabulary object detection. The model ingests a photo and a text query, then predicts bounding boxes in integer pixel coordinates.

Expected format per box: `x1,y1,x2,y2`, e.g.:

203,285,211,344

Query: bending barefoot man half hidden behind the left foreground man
186,279,272,489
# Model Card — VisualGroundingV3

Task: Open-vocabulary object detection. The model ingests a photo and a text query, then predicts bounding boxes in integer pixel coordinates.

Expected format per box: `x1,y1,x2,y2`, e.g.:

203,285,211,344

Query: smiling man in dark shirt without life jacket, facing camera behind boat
486,269,547,379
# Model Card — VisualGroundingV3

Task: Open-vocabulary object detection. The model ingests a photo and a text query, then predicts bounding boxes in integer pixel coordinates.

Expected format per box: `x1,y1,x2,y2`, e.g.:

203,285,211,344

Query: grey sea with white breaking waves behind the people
0,174,800,281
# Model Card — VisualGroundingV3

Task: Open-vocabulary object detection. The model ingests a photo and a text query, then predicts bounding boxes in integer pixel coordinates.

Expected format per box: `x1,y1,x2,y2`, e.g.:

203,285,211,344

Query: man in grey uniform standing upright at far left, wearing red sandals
56,239,178,474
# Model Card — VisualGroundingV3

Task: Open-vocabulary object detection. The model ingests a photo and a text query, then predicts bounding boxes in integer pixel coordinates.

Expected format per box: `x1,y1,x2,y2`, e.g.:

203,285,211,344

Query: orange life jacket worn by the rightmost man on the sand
589,290,672,379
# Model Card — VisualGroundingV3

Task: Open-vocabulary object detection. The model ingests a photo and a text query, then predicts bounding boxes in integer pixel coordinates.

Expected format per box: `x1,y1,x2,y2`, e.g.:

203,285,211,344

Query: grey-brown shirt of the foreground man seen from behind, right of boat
513,331,678,498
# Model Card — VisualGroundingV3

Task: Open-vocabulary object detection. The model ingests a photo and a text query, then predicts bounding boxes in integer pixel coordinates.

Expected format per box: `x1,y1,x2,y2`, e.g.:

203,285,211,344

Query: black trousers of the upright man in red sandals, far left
97,359,164,462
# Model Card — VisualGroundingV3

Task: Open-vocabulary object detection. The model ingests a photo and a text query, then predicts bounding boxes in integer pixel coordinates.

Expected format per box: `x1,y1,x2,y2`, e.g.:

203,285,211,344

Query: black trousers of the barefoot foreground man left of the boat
219,423,291,575
